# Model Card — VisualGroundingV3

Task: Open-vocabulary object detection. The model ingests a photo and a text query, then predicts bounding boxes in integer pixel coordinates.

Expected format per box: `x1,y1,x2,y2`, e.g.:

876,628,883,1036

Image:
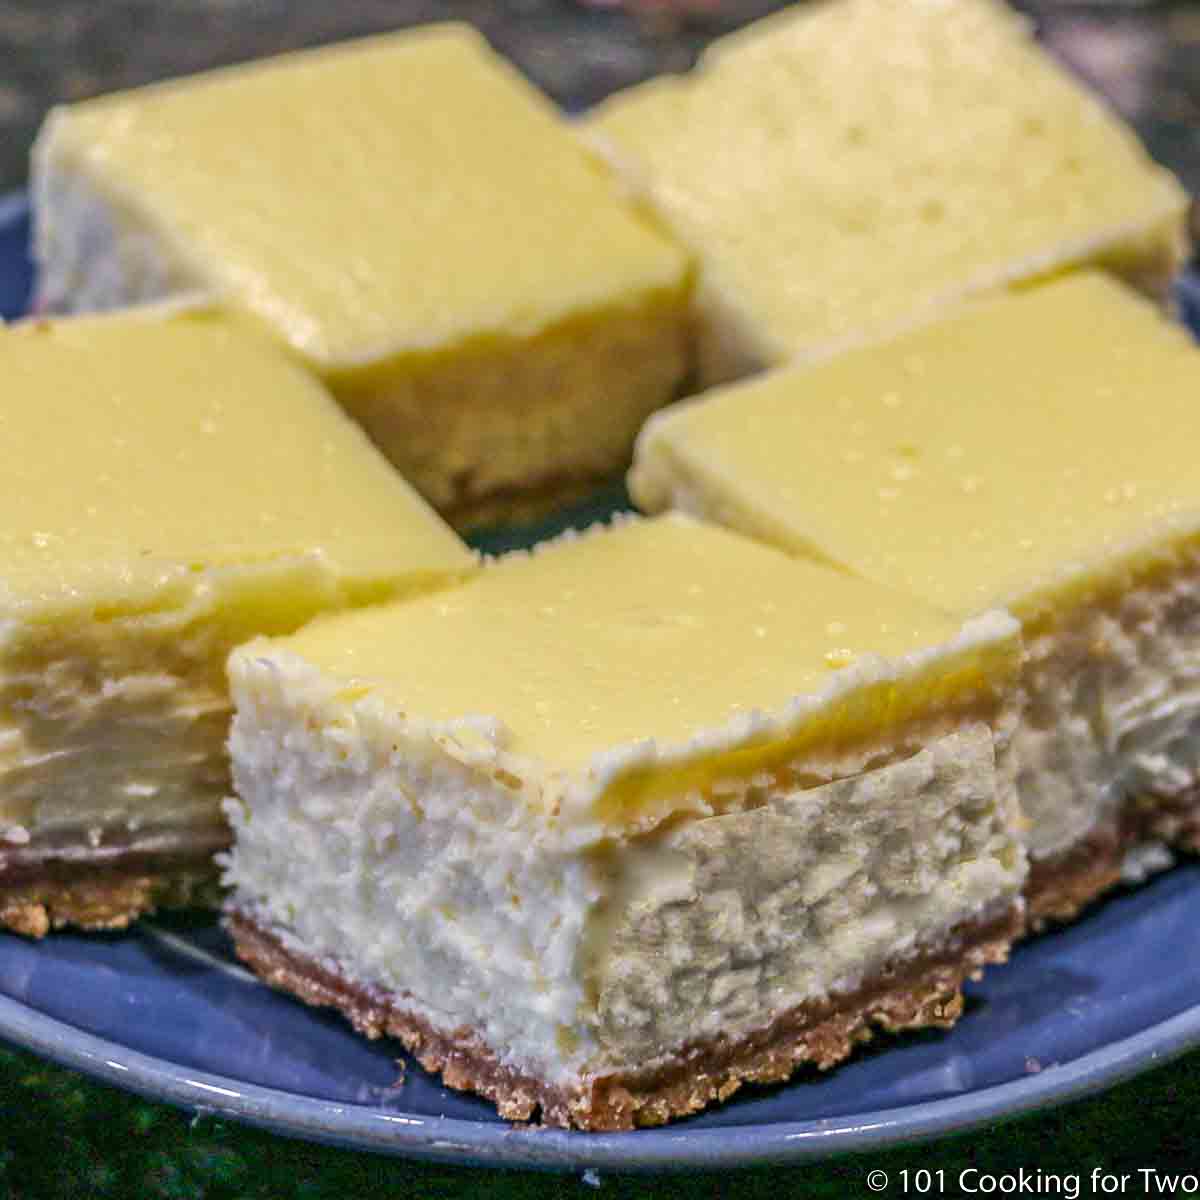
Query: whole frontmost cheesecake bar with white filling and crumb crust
224,515,1026,1129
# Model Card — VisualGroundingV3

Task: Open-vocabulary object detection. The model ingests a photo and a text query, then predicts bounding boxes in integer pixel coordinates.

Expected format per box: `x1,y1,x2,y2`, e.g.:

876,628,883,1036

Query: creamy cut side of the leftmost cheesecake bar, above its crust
0,557,369,846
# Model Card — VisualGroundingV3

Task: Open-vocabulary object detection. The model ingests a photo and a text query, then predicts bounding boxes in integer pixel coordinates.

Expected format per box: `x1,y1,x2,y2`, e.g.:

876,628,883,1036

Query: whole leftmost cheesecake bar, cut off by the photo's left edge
0,308,473,936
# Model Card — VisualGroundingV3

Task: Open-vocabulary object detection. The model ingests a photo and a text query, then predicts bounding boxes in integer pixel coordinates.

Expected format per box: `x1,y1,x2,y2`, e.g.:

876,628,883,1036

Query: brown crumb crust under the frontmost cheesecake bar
226,904,1024,1132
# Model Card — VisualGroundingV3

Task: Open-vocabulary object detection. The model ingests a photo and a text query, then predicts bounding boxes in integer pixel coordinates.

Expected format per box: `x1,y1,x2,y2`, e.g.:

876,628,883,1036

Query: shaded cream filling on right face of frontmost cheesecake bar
588,725,1026,1070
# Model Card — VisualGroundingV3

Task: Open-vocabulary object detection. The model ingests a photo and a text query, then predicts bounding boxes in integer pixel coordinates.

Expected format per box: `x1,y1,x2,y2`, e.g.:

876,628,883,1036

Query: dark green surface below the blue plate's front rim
0,1036,1200,1200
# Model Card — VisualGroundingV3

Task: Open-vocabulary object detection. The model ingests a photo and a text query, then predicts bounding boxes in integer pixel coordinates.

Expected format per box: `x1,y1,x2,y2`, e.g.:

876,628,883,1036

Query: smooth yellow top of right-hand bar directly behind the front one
631,274,1200,614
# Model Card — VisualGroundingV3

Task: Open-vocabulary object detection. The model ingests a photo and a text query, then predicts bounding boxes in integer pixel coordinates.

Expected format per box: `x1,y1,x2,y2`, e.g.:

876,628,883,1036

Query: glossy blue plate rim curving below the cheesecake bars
0,190,1200,1171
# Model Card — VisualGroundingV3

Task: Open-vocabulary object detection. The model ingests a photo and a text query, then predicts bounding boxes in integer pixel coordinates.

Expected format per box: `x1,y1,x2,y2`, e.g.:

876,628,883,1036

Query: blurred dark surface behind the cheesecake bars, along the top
0,0,1200,193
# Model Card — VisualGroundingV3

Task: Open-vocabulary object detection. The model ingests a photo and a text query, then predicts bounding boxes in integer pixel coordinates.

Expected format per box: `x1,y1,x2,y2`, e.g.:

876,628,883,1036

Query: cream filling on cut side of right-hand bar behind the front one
1014,558,1200,859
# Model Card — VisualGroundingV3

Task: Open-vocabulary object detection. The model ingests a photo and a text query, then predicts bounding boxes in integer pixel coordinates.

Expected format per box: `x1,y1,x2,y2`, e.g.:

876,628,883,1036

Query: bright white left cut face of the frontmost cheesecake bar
223,658,599,1082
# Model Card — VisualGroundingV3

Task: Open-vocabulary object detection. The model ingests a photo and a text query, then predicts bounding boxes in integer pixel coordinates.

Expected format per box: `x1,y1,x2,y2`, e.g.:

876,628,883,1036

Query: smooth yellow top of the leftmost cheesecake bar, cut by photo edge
0,308,473,616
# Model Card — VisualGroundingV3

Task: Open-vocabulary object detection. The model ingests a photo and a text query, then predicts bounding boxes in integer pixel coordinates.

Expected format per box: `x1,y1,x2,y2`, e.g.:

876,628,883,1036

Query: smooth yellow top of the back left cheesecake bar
47,25,685,372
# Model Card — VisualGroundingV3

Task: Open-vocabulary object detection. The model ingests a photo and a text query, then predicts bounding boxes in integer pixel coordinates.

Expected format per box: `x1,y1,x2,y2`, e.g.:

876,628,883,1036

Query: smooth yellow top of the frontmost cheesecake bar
272,515,1008,769
